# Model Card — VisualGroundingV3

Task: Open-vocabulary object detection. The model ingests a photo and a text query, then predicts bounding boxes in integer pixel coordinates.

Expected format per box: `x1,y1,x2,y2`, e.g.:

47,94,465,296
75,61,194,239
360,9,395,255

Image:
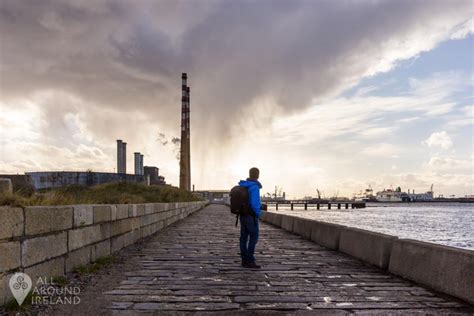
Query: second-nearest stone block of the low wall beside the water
339,227,397,269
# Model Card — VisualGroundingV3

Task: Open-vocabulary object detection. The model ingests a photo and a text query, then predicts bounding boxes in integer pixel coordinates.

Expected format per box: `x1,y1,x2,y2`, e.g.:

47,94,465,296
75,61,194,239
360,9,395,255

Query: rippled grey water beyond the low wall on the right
269,203,474,250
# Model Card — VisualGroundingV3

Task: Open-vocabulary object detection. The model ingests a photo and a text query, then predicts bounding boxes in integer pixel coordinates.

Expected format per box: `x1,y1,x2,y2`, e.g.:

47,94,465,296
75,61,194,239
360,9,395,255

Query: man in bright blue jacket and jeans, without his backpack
239,168,262,269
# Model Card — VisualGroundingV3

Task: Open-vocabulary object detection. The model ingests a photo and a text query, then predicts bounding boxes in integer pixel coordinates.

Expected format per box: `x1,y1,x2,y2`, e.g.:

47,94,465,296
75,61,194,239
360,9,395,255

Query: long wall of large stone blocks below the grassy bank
0,202,208,305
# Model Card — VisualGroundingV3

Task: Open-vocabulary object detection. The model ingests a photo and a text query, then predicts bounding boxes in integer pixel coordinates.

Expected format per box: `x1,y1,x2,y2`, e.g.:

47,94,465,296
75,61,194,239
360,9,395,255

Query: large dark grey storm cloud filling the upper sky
0,0,472,141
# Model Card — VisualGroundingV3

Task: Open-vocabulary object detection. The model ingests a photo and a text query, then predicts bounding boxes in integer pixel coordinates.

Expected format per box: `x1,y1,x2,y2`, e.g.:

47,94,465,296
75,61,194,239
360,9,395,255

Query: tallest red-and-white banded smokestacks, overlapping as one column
179,73,191,191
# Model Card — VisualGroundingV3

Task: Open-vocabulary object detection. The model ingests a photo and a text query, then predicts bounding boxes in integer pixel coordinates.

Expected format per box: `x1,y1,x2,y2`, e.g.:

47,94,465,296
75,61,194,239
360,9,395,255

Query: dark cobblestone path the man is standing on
106,205,473,315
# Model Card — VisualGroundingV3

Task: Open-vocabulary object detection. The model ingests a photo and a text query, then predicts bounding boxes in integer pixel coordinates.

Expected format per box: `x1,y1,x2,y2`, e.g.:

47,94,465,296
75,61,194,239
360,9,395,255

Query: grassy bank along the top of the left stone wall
0,182,201,207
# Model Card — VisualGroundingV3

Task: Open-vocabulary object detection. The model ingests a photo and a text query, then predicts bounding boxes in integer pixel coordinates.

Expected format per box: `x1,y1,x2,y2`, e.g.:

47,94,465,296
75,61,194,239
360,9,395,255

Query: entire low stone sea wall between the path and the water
261,211,474,304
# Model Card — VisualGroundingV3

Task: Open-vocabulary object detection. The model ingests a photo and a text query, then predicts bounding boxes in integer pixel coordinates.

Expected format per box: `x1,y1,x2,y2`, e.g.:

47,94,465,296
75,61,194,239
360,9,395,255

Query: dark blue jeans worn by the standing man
240,215,258,263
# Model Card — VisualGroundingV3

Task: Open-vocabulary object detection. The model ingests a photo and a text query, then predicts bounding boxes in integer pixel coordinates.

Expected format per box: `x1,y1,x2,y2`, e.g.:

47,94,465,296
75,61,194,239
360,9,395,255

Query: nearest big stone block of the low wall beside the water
388,239,474,304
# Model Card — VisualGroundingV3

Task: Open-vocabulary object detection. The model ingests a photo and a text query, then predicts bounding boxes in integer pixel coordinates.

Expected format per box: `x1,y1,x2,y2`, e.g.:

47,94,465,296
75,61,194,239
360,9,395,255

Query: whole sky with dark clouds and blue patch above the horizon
0,0,474,198
